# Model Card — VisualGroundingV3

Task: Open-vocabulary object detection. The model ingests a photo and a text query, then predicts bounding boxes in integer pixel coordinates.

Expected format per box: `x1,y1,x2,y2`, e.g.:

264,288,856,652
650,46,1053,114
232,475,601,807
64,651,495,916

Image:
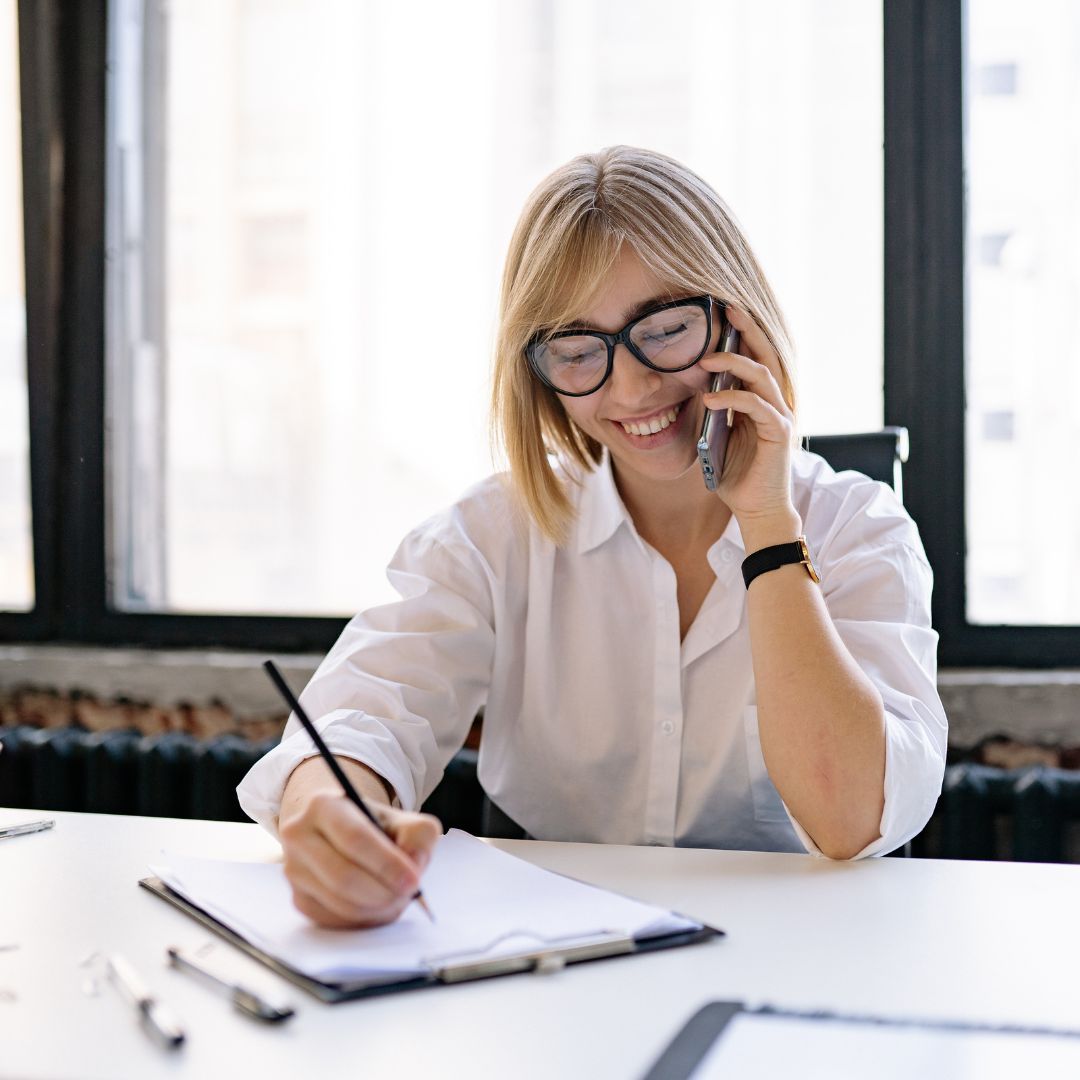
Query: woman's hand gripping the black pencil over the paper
279,758,443,929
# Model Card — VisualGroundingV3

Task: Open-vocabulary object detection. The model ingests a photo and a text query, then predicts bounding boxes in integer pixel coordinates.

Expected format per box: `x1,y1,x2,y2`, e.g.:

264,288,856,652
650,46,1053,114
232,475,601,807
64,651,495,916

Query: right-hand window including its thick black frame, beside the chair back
885,0,1080,667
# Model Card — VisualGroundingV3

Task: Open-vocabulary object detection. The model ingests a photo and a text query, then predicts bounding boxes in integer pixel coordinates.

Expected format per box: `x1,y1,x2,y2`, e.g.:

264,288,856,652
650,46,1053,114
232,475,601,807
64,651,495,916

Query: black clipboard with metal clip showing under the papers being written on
138,876,725,1004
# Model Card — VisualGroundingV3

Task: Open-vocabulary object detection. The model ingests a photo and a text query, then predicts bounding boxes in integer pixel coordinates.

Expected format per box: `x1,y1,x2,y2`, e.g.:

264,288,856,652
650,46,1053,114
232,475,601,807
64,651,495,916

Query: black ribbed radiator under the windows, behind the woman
0,726,1080,862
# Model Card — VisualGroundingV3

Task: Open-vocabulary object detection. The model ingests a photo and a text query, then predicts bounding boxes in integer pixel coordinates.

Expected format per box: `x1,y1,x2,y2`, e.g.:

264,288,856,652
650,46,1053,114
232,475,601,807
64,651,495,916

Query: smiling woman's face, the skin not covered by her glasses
559,246,720,480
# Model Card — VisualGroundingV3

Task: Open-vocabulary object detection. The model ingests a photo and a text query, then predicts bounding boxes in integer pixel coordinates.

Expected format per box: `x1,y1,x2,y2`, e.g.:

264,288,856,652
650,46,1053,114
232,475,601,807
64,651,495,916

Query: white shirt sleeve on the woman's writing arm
237,512,495,835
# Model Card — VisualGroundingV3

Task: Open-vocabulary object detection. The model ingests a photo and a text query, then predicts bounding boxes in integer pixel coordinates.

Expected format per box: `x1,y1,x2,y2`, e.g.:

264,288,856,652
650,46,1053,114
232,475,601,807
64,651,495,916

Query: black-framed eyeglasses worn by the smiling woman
525,296,724,397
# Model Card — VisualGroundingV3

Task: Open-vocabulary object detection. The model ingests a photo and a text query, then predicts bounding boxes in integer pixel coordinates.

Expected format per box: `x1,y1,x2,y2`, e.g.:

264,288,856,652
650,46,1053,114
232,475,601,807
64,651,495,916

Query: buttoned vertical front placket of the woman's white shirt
645,555,683,845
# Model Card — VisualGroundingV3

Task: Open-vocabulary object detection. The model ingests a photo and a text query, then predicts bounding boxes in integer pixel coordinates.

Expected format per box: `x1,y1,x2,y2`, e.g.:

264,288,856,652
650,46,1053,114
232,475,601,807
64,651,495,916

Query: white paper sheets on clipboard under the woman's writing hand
151,829,701,982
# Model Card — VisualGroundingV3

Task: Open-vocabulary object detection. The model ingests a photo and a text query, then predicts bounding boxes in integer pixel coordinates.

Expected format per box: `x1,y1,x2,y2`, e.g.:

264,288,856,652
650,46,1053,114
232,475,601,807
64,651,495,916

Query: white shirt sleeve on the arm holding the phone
789,481,948,859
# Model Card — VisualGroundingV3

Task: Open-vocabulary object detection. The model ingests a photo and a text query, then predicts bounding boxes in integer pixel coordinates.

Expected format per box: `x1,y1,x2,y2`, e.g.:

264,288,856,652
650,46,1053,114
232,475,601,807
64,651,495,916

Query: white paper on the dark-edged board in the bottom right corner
692,1015,1080,1080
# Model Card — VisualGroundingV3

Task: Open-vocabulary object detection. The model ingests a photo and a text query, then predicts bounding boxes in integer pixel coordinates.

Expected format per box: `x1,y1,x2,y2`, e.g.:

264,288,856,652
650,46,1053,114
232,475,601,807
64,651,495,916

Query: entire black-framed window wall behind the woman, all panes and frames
16,0,1080,666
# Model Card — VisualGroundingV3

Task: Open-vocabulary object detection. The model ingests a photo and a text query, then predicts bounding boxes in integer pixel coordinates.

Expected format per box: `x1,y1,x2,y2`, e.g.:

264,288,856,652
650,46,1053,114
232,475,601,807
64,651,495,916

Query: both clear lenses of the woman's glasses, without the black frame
532,303,708,394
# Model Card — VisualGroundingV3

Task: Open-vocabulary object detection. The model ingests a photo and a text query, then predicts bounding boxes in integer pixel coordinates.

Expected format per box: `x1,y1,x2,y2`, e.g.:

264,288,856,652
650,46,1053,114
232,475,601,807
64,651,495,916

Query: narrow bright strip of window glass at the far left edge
0,0,33,611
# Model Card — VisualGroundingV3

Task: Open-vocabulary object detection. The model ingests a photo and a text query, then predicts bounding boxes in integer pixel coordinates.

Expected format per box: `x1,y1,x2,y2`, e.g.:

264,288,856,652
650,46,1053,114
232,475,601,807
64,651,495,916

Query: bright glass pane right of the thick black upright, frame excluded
964,0,1080,624
